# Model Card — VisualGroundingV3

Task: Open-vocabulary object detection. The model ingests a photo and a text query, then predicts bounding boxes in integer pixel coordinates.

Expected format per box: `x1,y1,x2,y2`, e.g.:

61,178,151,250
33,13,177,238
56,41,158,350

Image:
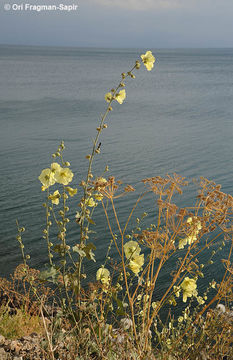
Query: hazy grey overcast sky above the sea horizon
0,0,233,48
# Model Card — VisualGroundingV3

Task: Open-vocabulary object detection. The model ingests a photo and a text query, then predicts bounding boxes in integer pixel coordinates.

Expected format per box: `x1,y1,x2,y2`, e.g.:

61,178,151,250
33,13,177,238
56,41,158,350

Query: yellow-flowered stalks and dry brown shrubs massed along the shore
0,51,233,360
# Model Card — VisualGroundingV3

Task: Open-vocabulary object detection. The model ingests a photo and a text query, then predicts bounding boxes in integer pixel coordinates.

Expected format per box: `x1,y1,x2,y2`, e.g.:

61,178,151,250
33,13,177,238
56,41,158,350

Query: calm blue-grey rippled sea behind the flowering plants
0,46,233,300
